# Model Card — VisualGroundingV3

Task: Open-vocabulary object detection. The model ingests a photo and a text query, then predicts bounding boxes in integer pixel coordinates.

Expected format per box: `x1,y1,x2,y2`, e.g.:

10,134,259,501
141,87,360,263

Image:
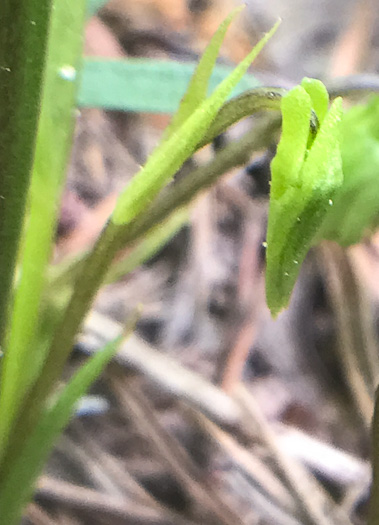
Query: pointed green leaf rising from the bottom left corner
0,336,123,525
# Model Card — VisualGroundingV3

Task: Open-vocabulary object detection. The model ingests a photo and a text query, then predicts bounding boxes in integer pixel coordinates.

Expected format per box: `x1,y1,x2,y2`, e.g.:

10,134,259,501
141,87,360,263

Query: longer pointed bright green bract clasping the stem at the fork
112,18,278,224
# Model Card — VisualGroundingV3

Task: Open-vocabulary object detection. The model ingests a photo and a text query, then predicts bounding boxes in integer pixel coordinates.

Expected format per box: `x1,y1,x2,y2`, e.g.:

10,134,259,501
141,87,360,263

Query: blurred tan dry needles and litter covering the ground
25,0,379,525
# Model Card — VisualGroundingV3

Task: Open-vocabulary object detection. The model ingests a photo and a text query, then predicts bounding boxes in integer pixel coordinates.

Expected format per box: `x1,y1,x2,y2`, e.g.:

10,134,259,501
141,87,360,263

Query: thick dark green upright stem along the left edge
0,0,51,344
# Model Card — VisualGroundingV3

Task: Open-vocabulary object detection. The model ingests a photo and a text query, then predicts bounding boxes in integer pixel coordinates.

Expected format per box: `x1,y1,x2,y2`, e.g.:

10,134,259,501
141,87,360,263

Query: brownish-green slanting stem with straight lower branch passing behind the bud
0,113,280,470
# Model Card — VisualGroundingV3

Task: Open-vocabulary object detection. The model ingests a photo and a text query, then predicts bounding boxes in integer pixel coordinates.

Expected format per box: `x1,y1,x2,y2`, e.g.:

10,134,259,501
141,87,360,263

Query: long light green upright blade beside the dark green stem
0,0,86,455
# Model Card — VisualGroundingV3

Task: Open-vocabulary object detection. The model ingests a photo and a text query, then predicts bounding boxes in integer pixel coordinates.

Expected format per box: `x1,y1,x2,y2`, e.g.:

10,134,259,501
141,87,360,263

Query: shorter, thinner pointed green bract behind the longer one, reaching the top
164,6,244,139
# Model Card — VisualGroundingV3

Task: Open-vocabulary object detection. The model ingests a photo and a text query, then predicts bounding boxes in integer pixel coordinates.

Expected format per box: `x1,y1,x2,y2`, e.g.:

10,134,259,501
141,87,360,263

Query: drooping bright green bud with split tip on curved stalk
266,87,343,316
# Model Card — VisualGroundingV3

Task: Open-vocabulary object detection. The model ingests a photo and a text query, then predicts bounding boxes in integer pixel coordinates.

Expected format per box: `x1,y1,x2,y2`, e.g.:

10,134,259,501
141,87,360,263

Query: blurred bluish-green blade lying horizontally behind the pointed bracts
77,57,259,114
